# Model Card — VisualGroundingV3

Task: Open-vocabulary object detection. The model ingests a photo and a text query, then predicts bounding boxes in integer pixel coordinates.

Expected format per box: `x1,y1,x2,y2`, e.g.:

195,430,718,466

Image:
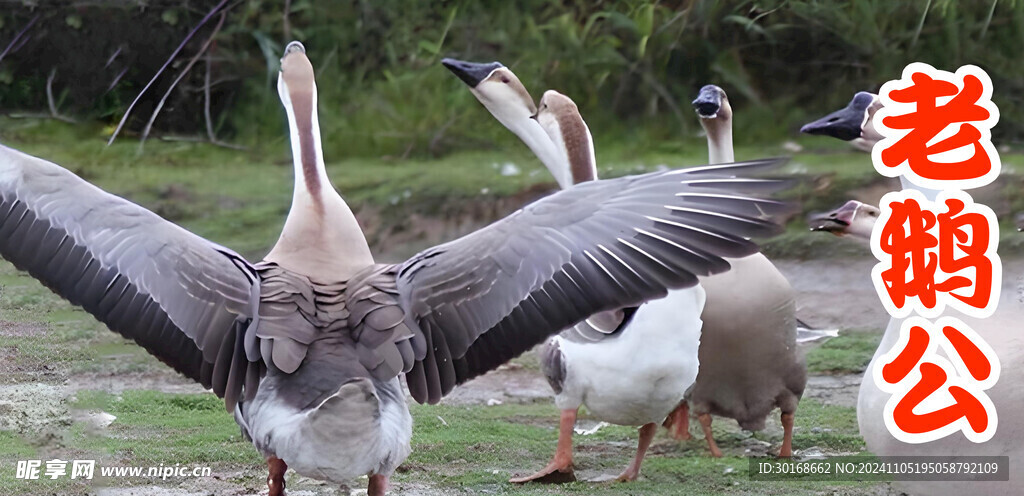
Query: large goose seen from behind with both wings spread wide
0,42,779,496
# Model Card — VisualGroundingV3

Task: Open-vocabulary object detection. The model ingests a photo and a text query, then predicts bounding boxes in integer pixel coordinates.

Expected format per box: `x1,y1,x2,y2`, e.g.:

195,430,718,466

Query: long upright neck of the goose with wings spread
266,63,374,281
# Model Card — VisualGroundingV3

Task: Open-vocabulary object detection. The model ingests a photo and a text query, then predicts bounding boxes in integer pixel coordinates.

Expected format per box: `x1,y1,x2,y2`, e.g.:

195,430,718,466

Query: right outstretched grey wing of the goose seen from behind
387,161,787,403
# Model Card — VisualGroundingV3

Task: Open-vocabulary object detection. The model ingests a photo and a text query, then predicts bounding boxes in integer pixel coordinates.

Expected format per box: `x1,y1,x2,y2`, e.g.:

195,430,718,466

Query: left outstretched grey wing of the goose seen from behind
0,146,264,409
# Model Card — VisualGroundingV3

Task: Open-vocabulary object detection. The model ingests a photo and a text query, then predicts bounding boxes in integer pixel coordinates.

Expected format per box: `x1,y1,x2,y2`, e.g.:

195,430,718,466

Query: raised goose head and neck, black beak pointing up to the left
441,58,572,189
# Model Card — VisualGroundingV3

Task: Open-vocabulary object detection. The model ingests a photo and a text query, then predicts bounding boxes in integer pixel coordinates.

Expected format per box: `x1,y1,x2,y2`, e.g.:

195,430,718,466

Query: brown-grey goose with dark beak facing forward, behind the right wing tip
687,85,807,457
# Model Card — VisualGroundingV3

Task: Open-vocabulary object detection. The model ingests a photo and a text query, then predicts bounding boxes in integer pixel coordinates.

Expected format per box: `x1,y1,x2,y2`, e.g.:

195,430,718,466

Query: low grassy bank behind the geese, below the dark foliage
8,117,1024,258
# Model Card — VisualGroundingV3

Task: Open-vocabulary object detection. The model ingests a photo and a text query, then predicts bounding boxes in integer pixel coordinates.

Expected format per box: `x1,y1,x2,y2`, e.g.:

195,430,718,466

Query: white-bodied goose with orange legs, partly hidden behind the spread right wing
528,90,704,483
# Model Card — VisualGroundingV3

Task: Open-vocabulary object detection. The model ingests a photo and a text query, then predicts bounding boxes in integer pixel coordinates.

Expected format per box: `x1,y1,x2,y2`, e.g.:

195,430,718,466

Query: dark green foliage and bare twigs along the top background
0,0,1024,157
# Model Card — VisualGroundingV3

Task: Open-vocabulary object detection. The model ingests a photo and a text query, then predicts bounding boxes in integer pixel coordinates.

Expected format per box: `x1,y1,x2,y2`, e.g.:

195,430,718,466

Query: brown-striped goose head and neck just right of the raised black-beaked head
534,89,597,183
